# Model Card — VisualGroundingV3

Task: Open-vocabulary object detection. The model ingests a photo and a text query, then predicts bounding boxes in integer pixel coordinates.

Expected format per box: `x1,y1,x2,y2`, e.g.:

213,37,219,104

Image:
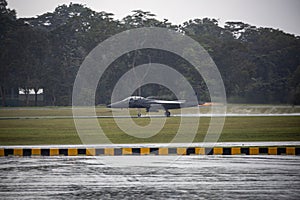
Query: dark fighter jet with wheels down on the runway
107,96,198,117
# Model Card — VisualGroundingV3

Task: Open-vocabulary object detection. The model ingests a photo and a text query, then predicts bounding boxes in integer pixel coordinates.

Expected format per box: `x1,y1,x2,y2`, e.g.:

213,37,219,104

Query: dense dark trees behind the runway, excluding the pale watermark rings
0,0,300,106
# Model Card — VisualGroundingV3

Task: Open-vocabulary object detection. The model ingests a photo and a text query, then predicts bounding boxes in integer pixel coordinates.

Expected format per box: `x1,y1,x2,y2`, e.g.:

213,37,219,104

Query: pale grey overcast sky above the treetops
7,0,300,36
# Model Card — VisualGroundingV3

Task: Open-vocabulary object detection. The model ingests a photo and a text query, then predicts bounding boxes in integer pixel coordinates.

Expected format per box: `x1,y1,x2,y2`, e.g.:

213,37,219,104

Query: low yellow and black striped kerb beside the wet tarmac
0,147,300,157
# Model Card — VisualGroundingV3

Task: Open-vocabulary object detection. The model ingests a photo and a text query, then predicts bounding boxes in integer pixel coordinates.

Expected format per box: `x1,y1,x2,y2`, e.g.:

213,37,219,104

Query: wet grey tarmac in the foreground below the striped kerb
0,156,300,199
